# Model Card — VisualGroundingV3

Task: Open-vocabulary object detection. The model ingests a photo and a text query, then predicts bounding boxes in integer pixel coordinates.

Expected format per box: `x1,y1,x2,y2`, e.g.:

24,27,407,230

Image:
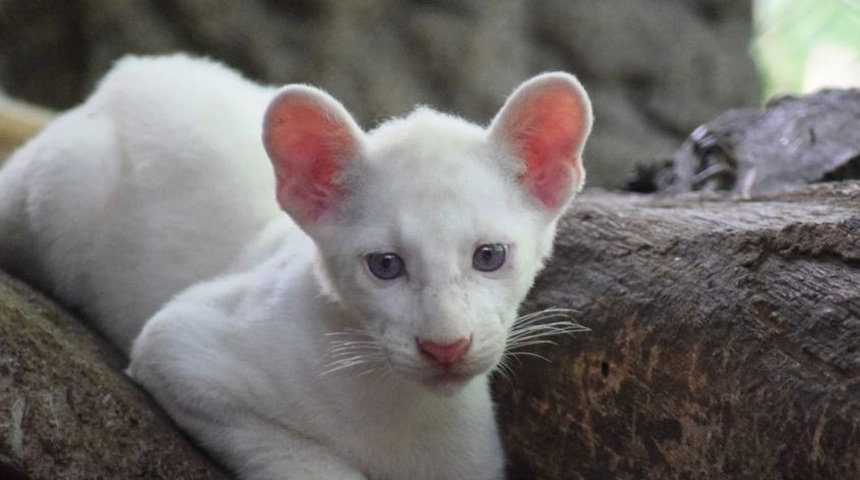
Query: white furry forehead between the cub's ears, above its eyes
344,110,532,248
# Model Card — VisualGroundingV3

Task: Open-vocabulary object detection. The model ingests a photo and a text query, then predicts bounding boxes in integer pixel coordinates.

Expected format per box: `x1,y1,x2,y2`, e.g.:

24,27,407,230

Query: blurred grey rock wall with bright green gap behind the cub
0,0,860,187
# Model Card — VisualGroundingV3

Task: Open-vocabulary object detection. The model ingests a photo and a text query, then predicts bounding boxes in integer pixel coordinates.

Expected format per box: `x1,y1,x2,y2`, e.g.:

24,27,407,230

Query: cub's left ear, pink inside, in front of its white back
263,85,362,225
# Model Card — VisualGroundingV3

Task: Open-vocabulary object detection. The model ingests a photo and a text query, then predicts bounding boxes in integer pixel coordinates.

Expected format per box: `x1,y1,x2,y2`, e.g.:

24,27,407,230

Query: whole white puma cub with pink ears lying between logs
0,56,592,480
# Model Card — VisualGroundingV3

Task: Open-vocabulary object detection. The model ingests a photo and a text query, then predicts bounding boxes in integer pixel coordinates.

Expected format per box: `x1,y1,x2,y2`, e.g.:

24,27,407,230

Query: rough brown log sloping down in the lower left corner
0,273,229,480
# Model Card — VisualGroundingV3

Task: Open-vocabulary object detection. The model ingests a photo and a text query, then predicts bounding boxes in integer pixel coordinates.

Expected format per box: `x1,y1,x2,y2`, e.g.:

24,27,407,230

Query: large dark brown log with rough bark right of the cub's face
496,182,860,480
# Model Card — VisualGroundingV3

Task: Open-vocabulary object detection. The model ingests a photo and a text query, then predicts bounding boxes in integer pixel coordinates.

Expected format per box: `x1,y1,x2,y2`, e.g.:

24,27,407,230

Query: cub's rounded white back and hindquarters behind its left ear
0,55,279,349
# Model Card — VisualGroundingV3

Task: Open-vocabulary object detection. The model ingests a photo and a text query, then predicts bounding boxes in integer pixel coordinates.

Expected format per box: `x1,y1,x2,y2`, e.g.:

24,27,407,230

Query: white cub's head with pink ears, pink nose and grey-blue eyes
264,73,592,391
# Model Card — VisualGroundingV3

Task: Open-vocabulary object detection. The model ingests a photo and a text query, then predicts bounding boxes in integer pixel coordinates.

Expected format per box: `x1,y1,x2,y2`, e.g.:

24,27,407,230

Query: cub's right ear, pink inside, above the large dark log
490,73,592,210
